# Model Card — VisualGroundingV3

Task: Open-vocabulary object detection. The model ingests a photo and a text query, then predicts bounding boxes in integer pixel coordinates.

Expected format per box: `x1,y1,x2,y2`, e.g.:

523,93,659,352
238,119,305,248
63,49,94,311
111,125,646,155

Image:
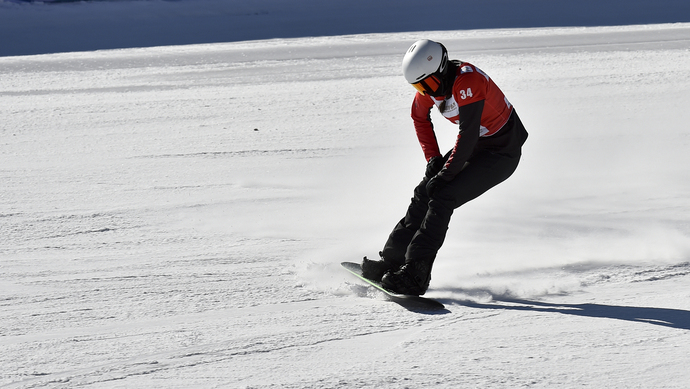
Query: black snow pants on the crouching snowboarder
383,133,520,264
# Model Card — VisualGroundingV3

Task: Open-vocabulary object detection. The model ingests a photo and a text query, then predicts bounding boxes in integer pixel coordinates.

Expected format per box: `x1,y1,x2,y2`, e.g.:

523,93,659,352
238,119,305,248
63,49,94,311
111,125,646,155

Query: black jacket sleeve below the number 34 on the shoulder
438,100,484,181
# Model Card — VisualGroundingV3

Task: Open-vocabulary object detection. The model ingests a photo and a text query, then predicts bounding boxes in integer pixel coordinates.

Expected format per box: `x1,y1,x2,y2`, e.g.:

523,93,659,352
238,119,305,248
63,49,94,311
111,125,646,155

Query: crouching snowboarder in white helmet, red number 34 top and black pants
362,40,527,295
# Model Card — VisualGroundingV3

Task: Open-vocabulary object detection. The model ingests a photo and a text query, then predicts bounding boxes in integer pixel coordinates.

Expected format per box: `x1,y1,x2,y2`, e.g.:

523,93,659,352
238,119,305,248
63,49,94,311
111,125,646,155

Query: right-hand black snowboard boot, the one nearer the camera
381,259,434,296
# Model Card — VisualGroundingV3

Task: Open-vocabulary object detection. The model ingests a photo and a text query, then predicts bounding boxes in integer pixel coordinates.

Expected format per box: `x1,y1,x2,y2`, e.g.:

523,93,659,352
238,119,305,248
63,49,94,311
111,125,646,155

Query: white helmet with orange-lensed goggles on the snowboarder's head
402,39,448,94
